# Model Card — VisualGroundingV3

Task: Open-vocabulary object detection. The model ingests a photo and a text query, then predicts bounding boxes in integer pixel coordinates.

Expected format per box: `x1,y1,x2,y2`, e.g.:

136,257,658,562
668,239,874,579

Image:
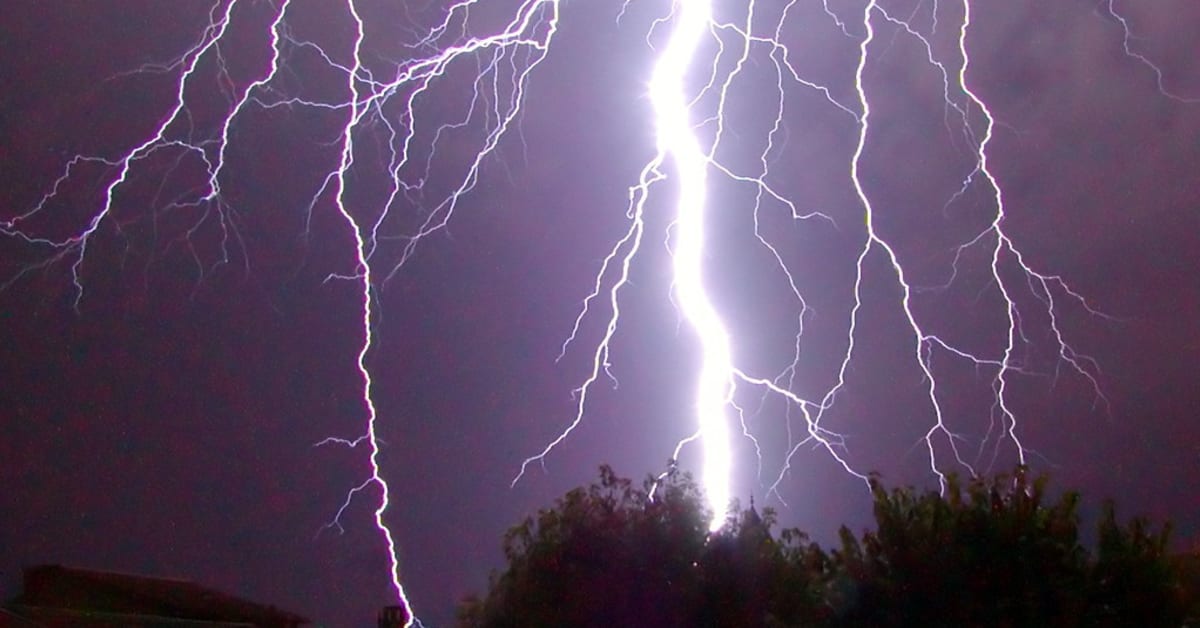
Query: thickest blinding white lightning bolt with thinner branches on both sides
512,0,1106,530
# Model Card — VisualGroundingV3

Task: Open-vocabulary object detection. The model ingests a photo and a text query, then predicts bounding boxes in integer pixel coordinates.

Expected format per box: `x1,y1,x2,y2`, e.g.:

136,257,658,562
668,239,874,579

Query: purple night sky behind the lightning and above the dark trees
0,0,1200,626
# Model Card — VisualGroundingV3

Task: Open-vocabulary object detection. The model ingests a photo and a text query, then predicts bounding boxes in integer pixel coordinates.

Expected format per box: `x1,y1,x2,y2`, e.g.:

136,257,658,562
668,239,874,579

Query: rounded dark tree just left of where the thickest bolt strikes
460,466,708,628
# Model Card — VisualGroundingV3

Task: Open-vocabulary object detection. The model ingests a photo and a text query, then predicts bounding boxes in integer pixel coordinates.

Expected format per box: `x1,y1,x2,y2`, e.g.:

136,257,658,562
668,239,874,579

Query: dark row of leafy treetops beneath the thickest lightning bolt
458,466,1187,628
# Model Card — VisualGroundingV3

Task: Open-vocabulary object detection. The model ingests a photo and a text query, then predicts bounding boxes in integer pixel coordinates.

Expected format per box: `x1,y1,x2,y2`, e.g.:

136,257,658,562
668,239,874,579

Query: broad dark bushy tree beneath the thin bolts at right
833,469,1087,627
